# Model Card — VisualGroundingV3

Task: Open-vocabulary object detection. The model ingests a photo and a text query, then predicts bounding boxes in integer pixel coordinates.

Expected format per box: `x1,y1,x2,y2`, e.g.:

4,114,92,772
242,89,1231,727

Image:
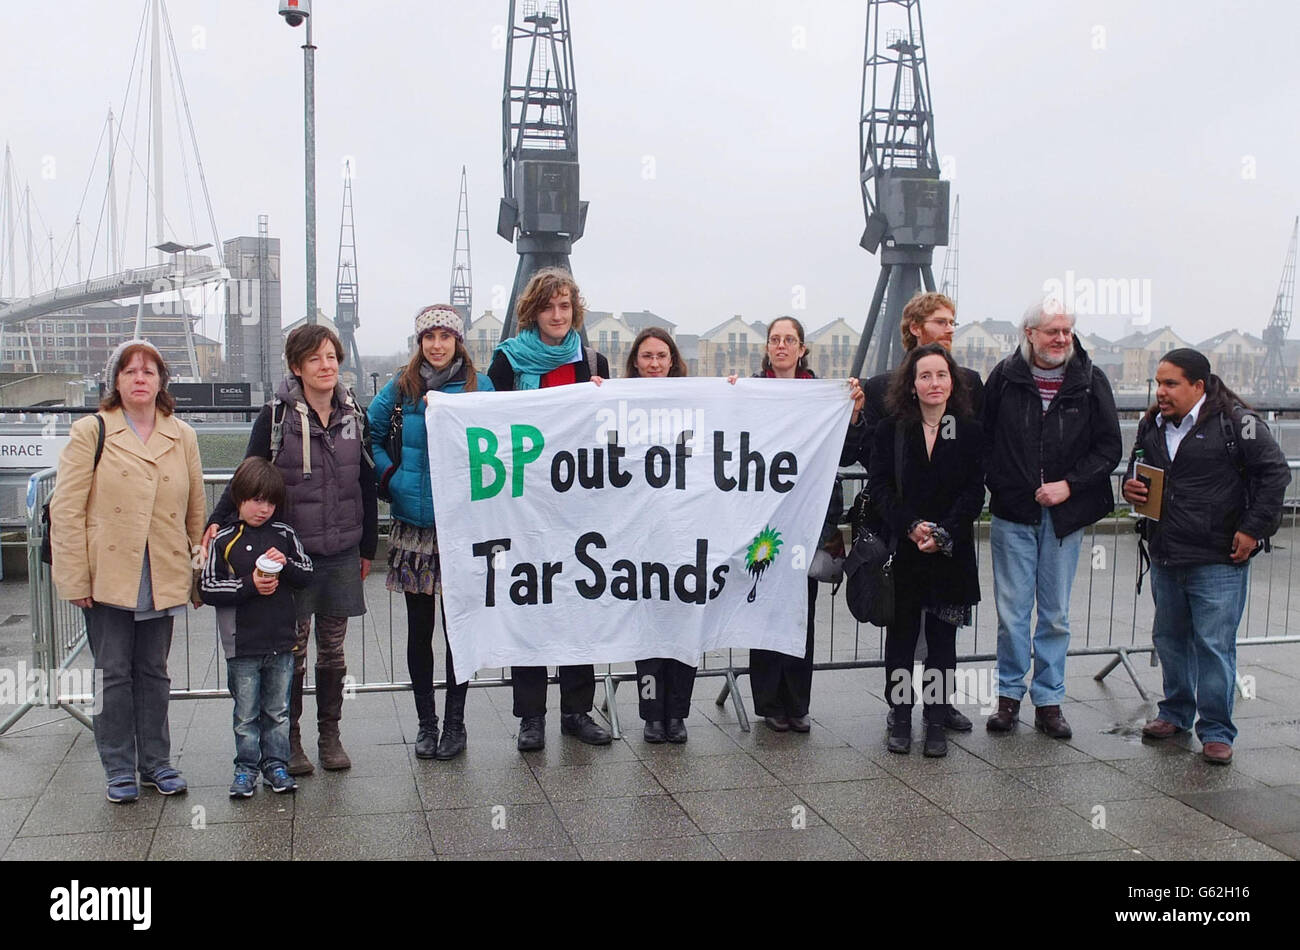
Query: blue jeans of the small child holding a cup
226,652,294,775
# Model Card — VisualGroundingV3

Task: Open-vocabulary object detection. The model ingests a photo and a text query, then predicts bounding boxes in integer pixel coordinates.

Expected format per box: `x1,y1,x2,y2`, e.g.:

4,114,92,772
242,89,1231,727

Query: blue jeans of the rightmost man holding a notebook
1151,563,1251,745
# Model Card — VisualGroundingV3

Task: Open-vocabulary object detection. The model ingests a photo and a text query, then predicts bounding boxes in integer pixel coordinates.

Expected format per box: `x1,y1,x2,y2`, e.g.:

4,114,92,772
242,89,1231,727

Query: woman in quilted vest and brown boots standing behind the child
204,324,378,775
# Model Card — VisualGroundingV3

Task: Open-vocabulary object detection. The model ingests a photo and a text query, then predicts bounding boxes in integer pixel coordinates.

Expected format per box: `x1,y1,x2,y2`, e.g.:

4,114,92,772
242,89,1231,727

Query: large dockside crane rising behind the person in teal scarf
497,0,588,339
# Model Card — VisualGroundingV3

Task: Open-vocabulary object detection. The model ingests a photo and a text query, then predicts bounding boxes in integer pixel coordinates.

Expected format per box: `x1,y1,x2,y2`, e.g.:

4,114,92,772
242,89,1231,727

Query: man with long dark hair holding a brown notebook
1123,348,1291,765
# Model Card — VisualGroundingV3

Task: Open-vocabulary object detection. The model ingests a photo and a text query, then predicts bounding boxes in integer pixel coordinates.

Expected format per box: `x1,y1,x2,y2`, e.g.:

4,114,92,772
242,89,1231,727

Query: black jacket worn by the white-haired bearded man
984,337,1123,538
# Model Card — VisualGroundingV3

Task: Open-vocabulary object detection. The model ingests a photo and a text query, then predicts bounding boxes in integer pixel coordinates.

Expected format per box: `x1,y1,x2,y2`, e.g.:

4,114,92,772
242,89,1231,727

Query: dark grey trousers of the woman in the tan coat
83,604,173,781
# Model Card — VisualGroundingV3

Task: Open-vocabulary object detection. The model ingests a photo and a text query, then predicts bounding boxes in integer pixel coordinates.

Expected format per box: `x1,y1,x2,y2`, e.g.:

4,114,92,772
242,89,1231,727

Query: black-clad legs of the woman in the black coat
885,574,957,712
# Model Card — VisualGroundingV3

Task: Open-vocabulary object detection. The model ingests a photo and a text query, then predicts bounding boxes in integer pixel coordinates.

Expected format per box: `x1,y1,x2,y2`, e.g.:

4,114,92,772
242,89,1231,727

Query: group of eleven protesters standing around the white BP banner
51,268,1290,802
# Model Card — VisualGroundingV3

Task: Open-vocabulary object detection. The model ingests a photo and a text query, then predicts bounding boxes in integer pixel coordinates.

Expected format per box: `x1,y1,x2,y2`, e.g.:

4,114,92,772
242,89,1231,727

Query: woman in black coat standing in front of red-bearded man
867,343,984,756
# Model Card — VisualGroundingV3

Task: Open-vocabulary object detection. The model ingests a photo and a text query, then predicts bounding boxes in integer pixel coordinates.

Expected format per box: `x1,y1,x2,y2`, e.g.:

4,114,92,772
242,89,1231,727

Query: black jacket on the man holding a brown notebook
1128,403,1291,568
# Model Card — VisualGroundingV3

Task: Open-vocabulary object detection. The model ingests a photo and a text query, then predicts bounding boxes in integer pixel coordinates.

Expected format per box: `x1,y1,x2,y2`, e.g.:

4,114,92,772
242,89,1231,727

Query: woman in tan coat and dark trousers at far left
49,339,204,802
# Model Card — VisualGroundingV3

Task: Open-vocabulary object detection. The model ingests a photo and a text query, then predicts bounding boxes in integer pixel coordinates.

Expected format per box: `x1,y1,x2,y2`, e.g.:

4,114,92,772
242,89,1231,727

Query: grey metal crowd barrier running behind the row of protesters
0,461,1300,737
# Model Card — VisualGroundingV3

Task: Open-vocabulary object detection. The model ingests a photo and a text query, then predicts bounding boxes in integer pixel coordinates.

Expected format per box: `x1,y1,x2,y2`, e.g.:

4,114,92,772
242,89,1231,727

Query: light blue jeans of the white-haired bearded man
989,508,1083,706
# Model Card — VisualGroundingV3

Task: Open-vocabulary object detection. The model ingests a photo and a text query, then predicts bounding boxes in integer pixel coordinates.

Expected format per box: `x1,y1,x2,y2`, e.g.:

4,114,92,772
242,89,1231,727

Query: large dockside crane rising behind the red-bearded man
853,0,950,376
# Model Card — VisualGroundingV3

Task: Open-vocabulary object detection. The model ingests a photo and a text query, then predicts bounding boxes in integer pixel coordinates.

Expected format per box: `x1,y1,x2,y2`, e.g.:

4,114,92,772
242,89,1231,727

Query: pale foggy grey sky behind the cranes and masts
0,0,1300,353
